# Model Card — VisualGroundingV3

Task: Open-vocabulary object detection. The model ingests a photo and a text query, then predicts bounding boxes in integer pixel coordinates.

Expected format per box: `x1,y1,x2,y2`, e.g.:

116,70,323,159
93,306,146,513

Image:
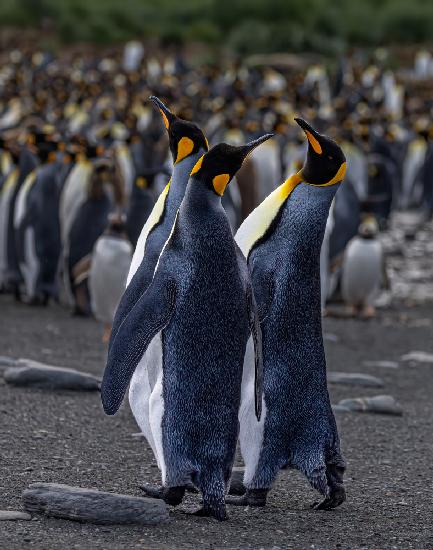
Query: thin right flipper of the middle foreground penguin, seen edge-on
236,244,263,420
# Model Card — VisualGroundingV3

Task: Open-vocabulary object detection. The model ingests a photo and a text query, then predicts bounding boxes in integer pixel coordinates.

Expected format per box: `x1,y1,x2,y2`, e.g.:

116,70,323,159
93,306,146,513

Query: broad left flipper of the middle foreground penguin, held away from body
101,277,176,415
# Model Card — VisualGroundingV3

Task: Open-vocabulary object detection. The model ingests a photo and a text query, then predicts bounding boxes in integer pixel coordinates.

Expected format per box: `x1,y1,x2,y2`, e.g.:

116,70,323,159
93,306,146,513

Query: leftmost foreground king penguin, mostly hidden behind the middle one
110,96,208,345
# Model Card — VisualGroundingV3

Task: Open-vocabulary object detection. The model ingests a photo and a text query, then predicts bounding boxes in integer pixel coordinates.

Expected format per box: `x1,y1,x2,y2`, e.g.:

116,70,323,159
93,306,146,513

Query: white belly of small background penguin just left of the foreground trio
89,235,132,324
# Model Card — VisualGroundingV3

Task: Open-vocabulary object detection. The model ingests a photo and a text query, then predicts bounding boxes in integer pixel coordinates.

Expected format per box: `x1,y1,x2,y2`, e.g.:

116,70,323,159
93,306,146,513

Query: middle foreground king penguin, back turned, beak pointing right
101,135,271,520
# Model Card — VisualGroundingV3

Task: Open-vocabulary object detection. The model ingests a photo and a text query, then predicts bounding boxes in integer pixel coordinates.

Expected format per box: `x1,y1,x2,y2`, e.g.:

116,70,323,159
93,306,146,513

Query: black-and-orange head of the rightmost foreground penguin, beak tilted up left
295,118,346,186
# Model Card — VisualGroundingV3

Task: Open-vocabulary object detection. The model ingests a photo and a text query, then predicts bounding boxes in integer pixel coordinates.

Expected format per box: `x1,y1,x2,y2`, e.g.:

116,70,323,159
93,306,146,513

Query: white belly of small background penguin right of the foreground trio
341,237,383,306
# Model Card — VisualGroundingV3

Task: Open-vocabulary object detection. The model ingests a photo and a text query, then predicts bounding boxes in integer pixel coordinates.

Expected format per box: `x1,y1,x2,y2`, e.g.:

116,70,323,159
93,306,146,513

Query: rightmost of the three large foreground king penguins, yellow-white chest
227,119,346,509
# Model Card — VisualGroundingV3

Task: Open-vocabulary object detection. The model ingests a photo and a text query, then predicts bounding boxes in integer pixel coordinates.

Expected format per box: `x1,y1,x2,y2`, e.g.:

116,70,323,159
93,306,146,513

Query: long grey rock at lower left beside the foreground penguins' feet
22,483,169,525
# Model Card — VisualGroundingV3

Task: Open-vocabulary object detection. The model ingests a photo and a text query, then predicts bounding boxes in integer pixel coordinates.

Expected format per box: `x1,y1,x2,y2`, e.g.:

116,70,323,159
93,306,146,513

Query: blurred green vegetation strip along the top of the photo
0,0,433,53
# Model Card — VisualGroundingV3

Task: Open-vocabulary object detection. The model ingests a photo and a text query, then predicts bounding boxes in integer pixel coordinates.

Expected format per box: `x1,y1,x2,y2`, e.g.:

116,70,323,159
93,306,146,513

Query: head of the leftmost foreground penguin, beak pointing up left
149,96,209,164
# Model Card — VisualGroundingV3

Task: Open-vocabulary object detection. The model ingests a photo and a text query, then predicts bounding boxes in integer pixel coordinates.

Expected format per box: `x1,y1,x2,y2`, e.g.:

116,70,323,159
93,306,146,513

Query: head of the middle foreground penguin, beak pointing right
191,134,274,196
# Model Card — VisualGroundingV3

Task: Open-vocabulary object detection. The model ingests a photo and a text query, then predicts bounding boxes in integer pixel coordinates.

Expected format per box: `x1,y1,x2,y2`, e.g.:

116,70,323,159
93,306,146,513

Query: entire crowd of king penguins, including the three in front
0,44,433,520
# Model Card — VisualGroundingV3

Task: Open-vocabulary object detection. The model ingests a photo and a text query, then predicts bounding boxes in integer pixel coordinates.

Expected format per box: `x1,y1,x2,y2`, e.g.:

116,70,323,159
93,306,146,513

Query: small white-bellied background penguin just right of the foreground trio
341,216,384,316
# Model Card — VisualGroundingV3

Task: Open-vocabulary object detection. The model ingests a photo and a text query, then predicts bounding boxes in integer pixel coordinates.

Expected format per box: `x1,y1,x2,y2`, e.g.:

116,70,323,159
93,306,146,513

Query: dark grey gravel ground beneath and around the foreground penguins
0,296,433,550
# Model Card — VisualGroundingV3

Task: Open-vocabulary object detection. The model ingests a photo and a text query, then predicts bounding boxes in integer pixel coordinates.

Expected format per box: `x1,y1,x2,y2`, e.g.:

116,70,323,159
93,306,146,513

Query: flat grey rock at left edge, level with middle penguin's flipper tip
4,359,100,391
